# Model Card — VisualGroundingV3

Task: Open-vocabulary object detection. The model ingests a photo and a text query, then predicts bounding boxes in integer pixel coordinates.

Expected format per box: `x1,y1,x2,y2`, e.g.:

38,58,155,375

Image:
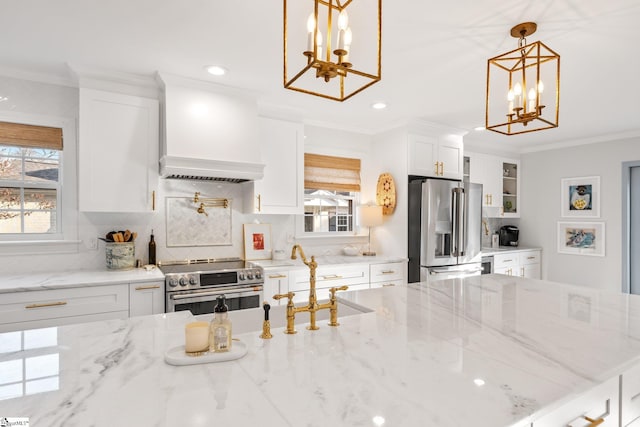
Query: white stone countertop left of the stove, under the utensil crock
0,267,164,294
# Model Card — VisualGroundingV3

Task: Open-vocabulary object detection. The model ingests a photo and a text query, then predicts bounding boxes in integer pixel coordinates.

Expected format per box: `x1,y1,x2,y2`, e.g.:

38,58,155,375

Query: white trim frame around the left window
0,111,80,255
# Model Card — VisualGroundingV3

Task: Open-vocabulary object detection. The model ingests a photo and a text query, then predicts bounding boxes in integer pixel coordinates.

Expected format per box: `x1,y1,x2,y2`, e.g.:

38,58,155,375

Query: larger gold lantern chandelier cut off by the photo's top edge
284,0,382,101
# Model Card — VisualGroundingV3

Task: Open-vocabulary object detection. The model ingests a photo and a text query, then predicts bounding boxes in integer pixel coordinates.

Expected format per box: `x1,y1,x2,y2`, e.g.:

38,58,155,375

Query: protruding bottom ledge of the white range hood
160,156,264,183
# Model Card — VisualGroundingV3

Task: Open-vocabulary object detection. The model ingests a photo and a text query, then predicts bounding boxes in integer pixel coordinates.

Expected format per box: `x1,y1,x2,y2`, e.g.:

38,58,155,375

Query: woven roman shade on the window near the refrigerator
304,153,360,192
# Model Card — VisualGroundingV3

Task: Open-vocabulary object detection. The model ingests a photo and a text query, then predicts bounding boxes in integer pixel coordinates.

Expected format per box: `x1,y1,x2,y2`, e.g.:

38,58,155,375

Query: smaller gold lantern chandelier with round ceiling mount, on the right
485,22,560,135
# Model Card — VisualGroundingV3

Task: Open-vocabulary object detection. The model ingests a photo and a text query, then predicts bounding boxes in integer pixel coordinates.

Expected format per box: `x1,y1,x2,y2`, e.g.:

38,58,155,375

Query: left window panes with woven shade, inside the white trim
0,122,62,235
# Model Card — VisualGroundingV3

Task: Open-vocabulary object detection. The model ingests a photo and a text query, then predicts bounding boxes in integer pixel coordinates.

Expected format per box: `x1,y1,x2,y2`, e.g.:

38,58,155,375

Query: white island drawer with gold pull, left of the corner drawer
531,376,624,427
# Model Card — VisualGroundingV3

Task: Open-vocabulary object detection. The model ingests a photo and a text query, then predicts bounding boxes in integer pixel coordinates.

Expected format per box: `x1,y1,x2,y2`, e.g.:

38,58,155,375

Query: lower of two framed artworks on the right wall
558,222,605,256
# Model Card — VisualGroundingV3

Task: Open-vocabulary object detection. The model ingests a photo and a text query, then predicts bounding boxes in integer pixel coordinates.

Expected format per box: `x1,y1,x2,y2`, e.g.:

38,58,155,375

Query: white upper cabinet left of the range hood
78,88,159,212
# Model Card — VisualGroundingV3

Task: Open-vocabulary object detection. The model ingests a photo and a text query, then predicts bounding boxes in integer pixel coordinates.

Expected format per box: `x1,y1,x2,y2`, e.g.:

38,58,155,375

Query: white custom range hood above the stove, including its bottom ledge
158,74,264,183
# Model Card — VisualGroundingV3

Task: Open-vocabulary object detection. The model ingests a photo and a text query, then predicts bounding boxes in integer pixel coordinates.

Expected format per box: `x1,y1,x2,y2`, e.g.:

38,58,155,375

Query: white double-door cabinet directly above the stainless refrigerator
408,133,463,179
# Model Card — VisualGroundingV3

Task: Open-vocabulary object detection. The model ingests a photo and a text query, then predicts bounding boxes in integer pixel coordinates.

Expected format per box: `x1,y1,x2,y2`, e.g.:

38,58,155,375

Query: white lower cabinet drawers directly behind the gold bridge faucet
289,264,369,302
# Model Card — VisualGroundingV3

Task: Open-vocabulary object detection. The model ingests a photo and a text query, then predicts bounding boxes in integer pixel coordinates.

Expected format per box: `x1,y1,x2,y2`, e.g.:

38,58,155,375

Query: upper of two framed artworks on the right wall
560,176,600,218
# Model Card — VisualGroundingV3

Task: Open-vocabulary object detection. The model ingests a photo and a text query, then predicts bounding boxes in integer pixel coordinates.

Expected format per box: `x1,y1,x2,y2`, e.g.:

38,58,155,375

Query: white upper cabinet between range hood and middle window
243,117,304,215
